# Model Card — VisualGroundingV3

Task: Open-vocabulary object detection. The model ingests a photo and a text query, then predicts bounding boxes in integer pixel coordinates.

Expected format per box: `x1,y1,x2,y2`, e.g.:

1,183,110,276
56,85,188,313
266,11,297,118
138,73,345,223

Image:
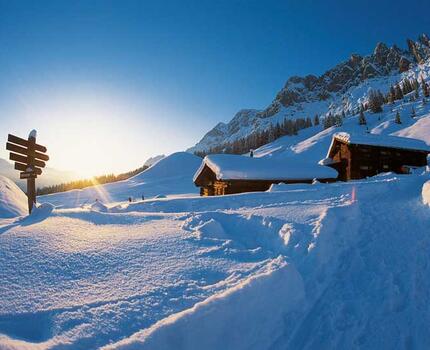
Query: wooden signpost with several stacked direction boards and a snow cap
6,130,49,214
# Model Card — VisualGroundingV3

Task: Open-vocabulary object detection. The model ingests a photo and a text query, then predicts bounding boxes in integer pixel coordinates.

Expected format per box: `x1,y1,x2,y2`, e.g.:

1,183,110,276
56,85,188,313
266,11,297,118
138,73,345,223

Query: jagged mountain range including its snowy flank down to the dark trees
187,34,430,152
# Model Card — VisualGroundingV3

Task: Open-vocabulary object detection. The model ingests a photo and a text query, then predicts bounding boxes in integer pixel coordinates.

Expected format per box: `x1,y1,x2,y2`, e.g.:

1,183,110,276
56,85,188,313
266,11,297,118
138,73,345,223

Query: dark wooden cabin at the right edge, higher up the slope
320,132,430,181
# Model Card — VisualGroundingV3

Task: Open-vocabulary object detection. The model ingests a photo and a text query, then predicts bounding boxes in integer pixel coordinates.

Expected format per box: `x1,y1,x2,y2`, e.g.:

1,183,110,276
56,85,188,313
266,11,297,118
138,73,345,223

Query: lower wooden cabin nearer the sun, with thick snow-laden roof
194,154,338,196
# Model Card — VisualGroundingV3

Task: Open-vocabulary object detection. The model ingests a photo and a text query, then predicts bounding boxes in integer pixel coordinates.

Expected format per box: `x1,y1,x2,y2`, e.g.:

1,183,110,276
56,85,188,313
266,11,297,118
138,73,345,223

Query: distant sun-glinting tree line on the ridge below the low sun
36,165,148,196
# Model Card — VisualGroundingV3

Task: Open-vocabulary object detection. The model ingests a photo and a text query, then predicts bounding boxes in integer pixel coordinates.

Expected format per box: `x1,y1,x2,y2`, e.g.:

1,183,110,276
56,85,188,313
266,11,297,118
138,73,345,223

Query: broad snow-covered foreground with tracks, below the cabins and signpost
0,169,430,349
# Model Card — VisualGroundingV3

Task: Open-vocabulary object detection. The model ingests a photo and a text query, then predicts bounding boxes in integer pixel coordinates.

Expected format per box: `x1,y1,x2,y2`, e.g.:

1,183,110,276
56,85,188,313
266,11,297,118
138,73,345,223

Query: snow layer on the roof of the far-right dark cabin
333,132,430,152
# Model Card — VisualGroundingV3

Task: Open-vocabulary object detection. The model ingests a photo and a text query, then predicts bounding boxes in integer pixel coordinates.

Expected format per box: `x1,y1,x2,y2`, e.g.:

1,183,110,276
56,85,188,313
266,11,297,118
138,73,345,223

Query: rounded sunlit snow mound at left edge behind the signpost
0,175,28,218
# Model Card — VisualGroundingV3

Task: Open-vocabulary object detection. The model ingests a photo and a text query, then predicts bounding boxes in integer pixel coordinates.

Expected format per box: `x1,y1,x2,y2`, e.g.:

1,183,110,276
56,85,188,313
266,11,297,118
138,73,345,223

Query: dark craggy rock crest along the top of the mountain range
190,34,430,150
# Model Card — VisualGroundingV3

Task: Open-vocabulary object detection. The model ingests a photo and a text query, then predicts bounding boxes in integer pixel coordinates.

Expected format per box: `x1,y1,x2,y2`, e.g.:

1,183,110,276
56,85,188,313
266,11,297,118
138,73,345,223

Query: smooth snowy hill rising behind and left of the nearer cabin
38,152,201,208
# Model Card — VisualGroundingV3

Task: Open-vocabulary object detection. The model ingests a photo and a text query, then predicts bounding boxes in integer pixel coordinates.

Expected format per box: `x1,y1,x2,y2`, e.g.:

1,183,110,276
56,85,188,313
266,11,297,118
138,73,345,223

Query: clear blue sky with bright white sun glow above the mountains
0,0,430,175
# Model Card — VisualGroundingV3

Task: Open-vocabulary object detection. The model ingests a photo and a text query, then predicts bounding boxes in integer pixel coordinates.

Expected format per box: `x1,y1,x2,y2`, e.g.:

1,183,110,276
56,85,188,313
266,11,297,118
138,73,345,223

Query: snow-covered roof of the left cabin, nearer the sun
194,154,337,181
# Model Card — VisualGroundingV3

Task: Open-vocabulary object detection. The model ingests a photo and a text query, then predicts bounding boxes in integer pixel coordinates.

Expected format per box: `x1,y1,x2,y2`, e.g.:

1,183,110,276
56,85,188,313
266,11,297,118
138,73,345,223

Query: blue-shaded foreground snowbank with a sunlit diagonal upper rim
106,257,304,350
